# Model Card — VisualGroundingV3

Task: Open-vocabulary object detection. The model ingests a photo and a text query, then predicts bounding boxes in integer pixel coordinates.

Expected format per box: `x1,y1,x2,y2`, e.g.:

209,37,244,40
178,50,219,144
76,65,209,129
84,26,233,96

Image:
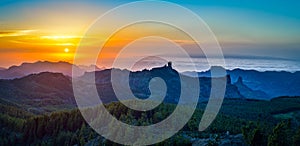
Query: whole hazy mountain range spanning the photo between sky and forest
0,62,300,113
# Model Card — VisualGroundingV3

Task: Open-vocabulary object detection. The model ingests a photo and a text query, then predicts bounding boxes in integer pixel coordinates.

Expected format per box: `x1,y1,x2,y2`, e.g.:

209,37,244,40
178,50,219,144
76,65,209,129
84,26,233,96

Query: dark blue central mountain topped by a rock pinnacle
79,66,244,103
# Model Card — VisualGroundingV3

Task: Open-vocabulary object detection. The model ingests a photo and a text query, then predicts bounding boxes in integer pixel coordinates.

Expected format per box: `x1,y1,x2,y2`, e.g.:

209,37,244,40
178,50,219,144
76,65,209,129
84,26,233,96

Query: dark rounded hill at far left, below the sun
0,72,75,113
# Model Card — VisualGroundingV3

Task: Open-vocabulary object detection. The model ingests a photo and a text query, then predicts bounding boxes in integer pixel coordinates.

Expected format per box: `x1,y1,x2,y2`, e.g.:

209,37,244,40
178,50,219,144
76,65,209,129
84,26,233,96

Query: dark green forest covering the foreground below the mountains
0,97,300,146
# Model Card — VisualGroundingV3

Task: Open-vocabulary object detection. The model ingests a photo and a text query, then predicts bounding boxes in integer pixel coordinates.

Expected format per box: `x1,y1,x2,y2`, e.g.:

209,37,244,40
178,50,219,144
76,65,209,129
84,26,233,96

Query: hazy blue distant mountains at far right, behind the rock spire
183,67,300,99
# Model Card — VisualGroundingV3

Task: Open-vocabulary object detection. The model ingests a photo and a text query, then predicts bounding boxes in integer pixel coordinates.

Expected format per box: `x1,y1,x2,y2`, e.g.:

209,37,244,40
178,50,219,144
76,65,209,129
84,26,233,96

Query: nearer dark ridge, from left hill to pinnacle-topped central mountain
0,67,244,113
